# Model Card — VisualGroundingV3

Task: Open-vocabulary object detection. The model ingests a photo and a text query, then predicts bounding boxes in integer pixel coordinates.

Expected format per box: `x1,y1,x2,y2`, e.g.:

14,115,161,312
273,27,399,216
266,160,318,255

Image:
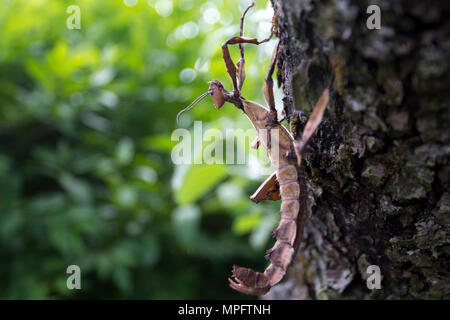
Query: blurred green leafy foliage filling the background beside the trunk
0,0,278,299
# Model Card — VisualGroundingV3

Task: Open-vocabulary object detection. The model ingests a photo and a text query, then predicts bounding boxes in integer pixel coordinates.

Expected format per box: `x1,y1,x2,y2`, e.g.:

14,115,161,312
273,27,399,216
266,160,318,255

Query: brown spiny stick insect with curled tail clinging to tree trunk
177,3,332,295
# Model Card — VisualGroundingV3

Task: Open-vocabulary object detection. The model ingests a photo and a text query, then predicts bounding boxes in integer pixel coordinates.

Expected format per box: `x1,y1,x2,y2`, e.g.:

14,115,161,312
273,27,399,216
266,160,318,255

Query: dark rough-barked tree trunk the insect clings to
263,0,450,299
